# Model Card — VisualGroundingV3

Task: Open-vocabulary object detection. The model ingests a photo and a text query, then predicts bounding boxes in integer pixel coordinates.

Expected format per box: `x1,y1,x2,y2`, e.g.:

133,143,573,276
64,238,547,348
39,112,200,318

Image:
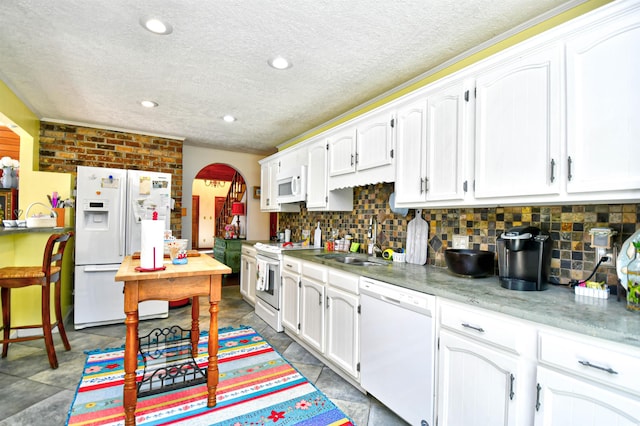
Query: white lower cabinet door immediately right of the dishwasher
438,330,530,426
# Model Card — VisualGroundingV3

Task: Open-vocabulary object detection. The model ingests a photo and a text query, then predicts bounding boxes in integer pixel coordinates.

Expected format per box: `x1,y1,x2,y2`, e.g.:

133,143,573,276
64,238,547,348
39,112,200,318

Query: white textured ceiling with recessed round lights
0,0,580,154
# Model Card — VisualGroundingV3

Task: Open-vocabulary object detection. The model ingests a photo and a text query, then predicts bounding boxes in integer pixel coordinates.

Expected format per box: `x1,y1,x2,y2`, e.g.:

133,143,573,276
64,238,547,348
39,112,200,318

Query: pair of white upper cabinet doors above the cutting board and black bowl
395,80,473,205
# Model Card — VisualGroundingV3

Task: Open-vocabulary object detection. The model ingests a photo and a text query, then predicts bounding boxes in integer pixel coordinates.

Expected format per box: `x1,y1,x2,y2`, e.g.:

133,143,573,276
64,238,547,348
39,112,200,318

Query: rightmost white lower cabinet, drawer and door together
535,330,640,426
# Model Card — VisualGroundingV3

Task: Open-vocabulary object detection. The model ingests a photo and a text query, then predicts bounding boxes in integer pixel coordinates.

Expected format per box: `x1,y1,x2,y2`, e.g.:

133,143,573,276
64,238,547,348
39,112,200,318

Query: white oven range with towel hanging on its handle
254,243,313,332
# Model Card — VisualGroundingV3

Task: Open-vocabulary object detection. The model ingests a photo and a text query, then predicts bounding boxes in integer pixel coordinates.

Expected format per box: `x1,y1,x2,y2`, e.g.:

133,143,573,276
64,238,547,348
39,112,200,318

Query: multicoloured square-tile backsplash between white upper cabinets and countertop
279,184,640,285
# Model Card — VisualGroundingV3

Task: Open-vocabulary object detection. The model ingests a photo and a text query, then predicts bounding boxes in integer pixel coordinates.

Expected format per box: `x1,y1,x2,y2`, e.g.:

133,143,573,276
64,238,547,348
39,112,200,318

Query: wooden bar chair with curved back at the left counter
0,232,73,368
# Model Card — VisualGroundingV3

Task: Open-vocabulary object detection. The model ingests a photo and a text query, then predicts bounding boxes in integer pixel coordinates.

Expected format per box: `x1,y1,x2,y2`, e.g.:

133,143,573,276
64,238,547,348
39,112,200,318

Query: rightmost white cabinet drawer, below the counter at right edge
538,331,640,395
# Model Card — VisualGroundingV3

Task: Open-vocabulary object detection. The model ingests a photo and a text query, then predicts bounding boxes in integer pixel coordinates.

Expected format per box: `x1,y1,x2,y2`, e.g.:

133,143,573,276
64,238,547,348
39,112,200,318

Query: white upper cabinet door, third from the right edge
424,82,473,201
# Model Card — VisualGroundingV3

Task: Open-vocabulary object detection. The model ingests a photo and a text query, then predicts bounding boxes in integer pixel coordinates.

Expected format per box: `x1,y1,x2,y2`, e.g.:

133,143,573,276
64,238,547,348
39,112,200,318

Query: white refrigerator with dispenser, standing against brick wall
74,166,171,329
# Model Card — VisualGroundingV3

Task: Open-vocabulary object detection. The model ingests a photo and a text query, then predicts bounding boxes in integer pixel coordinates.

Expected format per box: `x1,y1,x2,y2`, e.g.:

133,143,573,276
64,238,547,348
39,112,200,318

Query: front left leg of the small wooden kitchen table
123,309,138,426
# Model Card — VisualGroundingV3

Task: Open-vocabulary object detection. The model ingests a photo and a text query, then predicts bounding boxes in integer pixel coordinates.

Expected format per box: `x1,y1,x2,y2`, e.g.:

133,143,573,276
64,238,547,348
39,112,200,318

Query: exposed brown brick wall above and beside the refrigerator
40,121,182,237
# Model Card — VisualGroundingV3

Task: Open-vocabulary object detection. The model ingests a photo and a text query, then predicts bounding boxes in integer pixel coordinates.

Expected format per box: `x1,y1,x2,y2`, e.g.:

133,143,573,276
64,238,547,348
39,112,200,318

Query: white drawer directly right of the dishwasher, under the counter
440,302,536,357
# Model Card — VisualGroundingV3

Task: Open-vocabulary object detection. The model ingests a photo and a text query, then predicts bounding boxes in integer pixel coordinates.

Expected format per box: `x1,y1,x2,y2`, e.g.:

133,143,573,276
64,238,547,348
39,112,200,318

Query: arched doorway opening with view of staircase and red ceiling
191,163,247,250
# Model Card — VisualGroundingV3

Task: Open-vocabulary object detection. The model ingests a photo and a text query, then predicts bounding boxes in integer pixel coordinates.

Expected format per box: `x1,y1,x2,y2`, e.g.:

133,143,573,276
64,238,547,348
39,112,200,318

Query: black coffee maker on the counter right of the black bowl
497,226,552,291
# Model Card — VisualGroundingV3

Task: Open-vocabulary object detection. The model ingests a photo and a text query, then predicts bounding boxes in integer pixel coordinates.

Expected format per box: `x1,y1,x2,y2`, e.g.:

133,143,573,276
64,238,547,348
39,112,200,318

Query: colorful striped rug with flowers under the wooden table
67,327,352,426
